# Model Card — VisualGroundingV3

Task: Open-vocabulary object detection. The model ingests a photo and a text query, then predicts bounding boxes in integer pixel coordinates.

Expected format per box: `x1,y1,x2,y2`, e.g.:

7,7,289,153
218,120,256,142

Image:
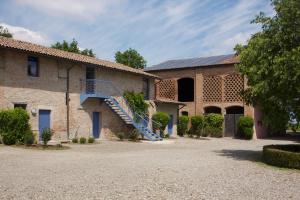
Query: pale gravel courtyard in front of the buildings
0,138,300,200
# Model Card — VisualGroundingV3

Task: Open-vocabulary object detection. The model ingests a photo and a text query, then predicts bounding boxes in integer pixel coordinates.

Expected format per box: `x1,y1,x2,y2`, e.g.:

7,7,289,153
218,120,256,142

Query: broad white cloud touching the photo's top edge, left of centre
14,0,123,19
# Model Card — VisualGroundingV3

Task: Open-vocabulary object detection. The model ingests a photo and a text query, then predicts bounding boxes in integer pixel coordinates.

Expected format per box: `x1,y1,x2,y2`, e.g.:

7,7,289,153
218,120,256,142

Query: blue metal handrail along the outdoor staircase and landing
80,79,160,132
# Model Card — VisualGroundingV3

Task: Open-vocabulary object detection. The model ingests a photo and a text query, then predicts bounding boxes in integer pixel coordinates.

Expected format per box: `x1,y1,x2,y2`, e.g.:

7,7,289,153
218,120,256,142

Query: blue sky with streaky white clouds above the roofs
0,0,274,66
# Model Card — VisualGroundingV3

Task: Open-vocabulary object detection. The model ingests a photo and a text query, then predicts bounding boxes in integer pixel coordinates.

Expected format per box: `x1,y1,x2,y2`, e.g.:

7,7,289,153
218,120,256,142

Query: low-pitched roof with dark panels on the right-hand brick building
144,54,239,72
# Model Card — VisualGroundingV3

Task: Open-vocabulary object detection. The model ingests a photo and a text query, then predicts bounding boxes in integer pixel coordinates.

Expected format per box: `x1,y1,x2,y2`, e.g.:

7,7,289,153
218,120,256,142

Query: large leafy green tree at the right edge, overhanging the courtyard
235,0,300,133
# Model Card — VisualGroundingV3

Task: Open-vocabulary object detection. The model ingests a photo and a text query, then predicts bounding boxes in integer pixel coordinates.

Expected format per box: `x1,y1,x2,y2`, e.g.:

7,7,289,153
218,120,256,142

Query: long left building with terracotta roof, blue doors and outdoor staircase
0,37,177,140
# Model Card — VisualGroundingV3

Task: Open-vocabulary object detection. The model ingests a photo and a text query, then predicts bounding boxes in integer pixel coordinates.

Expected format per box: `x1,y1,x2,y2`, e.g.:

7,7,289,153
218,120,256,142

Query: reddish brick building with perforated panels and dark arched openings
144,54,266,138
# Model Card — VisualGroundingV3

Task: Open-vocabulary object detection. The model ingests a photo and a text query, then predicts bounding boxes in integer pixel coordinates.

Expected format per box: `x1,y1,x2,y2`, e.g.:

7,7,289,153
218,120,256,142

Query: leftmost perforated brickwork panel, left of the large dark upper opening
158,79,176,100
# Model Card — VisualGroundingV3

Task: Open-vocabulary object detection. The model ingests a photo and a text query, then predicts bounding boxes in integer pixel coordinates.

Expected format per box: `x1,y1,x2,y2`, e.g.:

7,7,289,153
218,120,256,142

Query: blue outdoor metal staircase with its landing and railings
80,79,162,141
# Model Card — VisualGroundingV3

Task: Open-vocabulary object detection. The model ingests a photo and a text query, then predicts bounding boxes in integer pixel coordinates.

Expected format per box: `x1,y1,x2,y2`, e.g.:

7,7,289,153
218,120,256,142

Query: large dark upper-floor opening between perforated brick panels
177,78,194,102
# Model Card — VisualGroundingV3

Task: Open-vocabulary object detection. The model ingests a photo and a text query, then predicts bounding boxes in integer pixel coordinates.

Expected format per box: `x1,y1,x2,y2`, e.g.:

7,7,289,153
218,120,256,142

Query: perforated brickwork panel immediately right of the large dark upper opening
203,76,222,102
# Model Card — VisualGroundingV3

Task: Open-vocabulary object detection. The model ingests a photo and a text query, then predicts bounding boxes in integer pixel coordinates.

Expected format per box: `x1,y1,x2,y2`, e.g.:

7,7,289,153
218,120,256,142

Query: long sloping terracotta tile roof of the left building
0,36,157,78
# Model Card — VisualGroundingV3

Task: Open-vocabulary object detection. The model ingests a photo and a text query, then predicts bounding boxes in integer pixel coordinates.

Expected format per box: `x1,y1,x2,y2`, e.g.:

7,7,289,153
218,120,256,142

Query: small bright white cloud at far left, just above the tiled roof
0,23,50,45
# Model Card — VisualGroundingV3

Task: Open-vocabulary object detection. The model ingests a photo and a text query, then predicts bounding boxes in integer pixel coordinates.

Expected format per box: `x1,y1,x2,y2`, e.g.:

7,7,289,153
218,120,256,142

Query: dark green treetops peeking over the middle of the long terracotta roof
51,39,96,57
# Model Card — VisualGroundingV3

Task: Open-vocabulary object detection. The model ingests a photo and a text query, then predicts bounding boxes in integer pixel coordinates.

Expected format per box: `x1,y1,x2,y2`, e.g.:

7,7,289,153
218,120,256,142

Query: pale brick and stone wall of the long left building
0,49,154,140
